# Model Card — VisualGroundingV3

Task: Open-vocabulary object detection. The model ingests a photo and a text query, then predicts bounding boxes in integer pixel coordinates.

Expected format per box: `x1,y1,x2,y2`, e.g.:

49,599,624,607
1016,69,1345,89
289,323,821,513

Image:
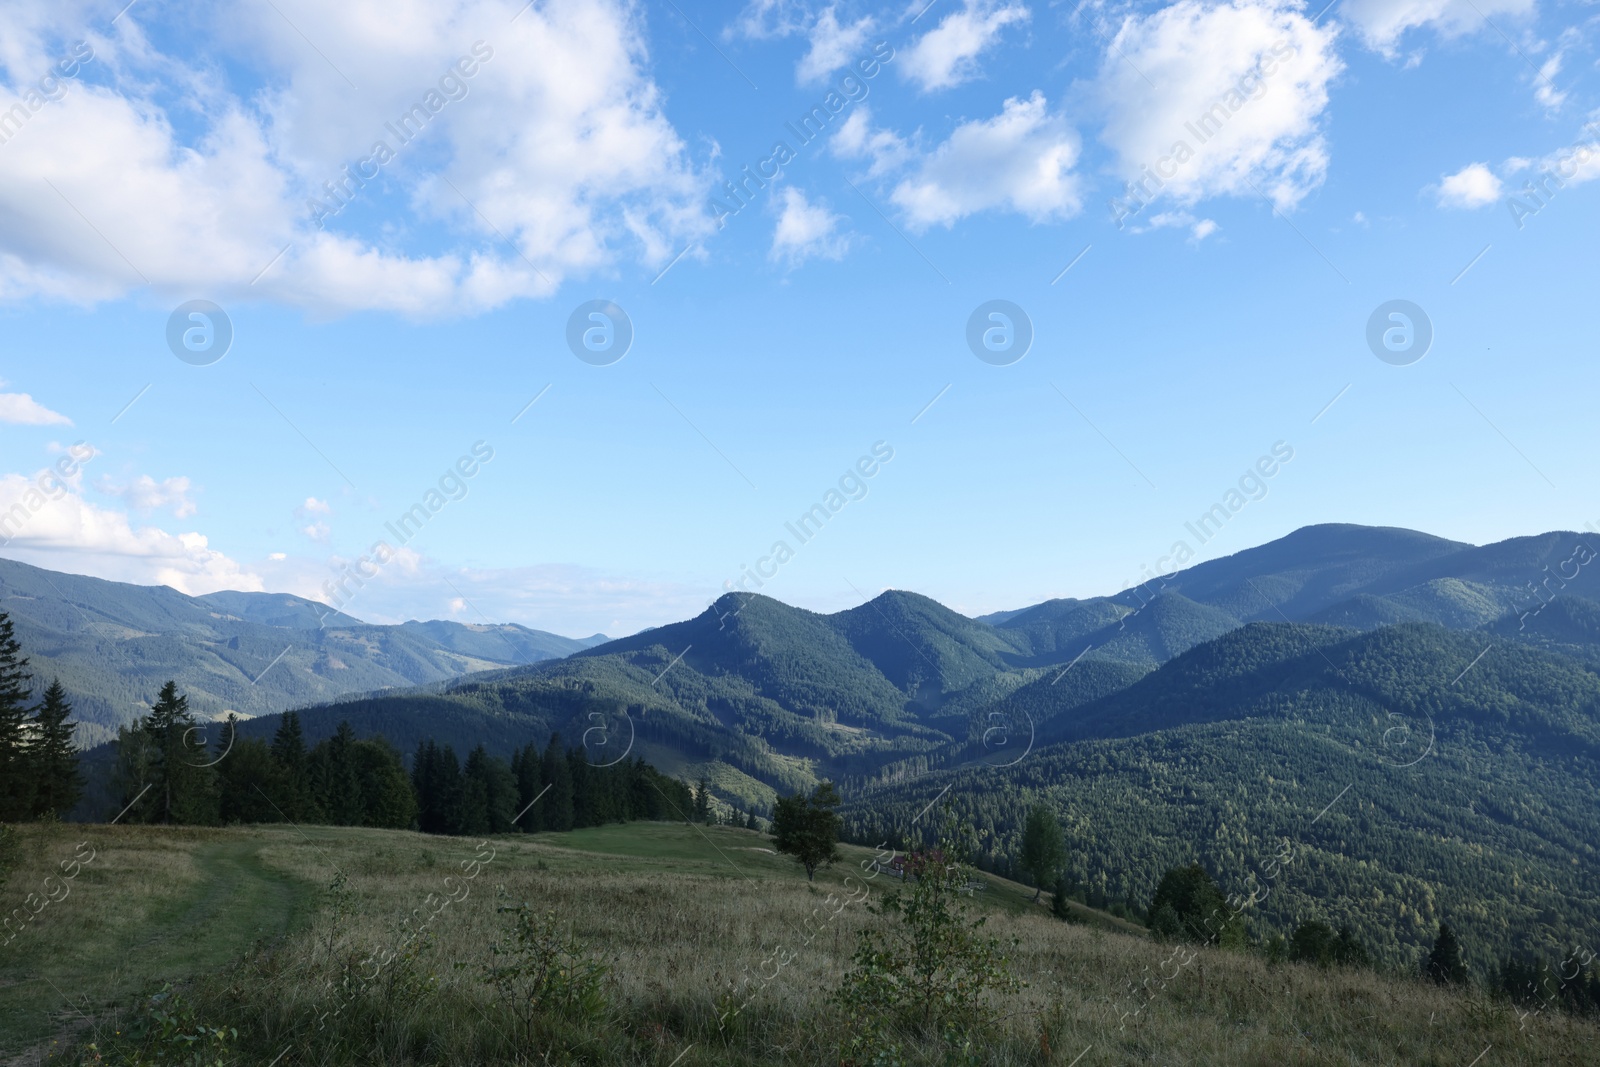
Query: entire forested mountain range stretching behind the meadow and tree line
12,525,1600,966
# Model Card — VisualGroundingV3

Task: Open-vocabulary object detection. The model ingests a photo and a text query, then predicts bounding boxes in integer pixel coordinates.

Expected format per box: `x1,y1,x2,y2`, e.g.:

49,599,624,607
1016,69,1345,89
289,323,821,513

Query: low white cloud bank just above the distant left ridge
0,472,262,595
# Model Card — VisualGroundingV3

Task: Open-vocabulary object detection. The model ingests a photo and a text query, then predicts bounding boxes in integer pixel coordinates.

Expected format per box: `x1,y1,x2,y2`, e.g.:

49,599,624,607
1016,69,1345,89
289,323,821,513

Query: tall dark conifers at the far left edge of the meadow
0,611,83,822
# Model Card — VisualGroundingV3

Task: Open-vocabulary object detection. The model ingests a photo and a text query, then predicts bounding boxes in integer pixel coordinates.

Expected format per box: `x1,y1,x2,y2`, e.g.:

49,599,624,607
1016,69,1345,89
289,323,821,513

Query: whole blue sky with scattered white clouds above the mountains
0,0,1600,635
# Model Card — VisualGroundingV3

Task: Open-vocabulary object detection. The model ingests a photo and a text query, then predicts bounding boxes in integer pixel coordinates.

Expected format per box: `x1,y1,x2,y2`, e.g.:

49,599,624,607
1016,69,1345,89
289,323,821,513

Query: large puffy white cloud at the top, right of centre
1099,0,1342,221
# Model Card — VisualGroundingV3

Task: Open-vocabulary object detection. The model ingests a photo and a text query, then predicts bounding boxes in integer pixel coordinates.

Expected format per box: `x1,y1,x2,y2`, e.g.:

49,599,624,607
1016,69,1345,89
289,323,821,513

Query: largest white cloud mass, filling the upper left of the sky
0,0,710,317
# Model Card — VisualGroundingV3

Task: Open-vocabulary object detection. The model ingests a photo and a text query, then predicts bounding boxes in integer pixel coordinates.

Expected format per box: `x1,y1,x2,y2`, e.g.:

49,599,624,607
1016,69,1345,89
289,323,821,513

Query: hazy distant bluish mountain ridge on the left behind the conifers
0,560,595,744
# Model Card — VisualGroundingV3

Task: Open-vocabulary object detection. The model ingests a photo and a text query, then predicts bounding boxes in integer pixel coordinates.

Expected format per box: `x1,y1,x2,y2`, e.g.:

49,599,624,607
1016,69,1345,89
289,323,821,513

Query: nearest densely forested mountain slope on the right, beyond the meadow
845,622,1600,974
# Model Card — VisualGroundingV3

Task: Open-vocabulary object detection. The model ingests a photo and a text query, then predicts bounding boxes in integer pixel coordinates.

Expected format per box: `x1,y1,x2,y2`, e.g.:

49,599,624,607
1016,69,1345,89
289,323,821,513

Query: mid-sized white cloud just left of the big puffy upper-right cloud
890,91,1082,230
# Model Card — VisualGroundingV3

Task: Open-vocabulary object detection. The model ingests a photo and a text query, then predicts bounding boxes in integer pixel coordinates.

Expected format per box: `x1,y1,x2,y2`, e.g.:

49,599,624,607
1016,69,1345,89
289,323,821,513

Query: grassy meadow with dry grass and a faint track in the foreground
0,824,1600,1067
